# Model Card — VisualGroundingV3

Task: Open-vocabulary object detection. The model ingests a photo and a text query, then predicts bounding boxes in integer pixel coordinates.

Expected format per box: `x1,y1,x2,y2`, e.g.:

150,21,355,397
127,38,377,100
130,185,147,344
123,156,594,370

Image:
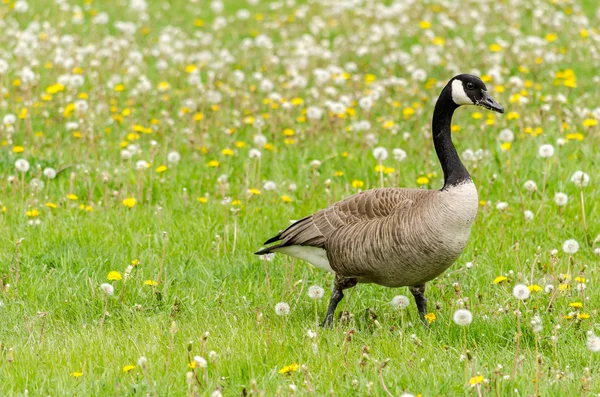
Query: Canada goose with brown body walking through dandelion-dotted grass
256,74,504,326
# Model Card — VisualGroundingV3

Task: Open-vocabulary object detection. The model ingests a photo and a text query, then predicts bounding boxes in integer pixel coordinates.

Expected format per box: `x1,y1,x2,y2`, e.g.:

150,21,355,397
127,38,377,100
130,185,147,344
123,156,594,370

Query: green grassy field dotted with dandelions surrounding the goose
0,0,600,396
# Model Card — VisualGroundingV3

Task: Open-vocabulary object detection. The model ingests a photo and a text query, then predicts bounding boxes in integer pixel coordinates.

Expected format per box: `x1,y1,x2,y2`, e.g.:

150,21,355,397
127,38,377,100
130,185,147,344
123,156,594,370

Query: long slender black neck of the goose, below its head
431,87,471,190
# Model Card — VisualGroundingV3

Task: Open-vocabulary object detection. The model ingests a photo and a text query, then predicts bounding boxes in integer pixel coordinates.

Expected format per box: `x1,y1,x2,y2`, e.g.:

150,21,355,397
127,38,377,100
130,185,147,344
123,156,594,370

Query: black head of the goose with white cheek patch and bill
449,74,504,113
